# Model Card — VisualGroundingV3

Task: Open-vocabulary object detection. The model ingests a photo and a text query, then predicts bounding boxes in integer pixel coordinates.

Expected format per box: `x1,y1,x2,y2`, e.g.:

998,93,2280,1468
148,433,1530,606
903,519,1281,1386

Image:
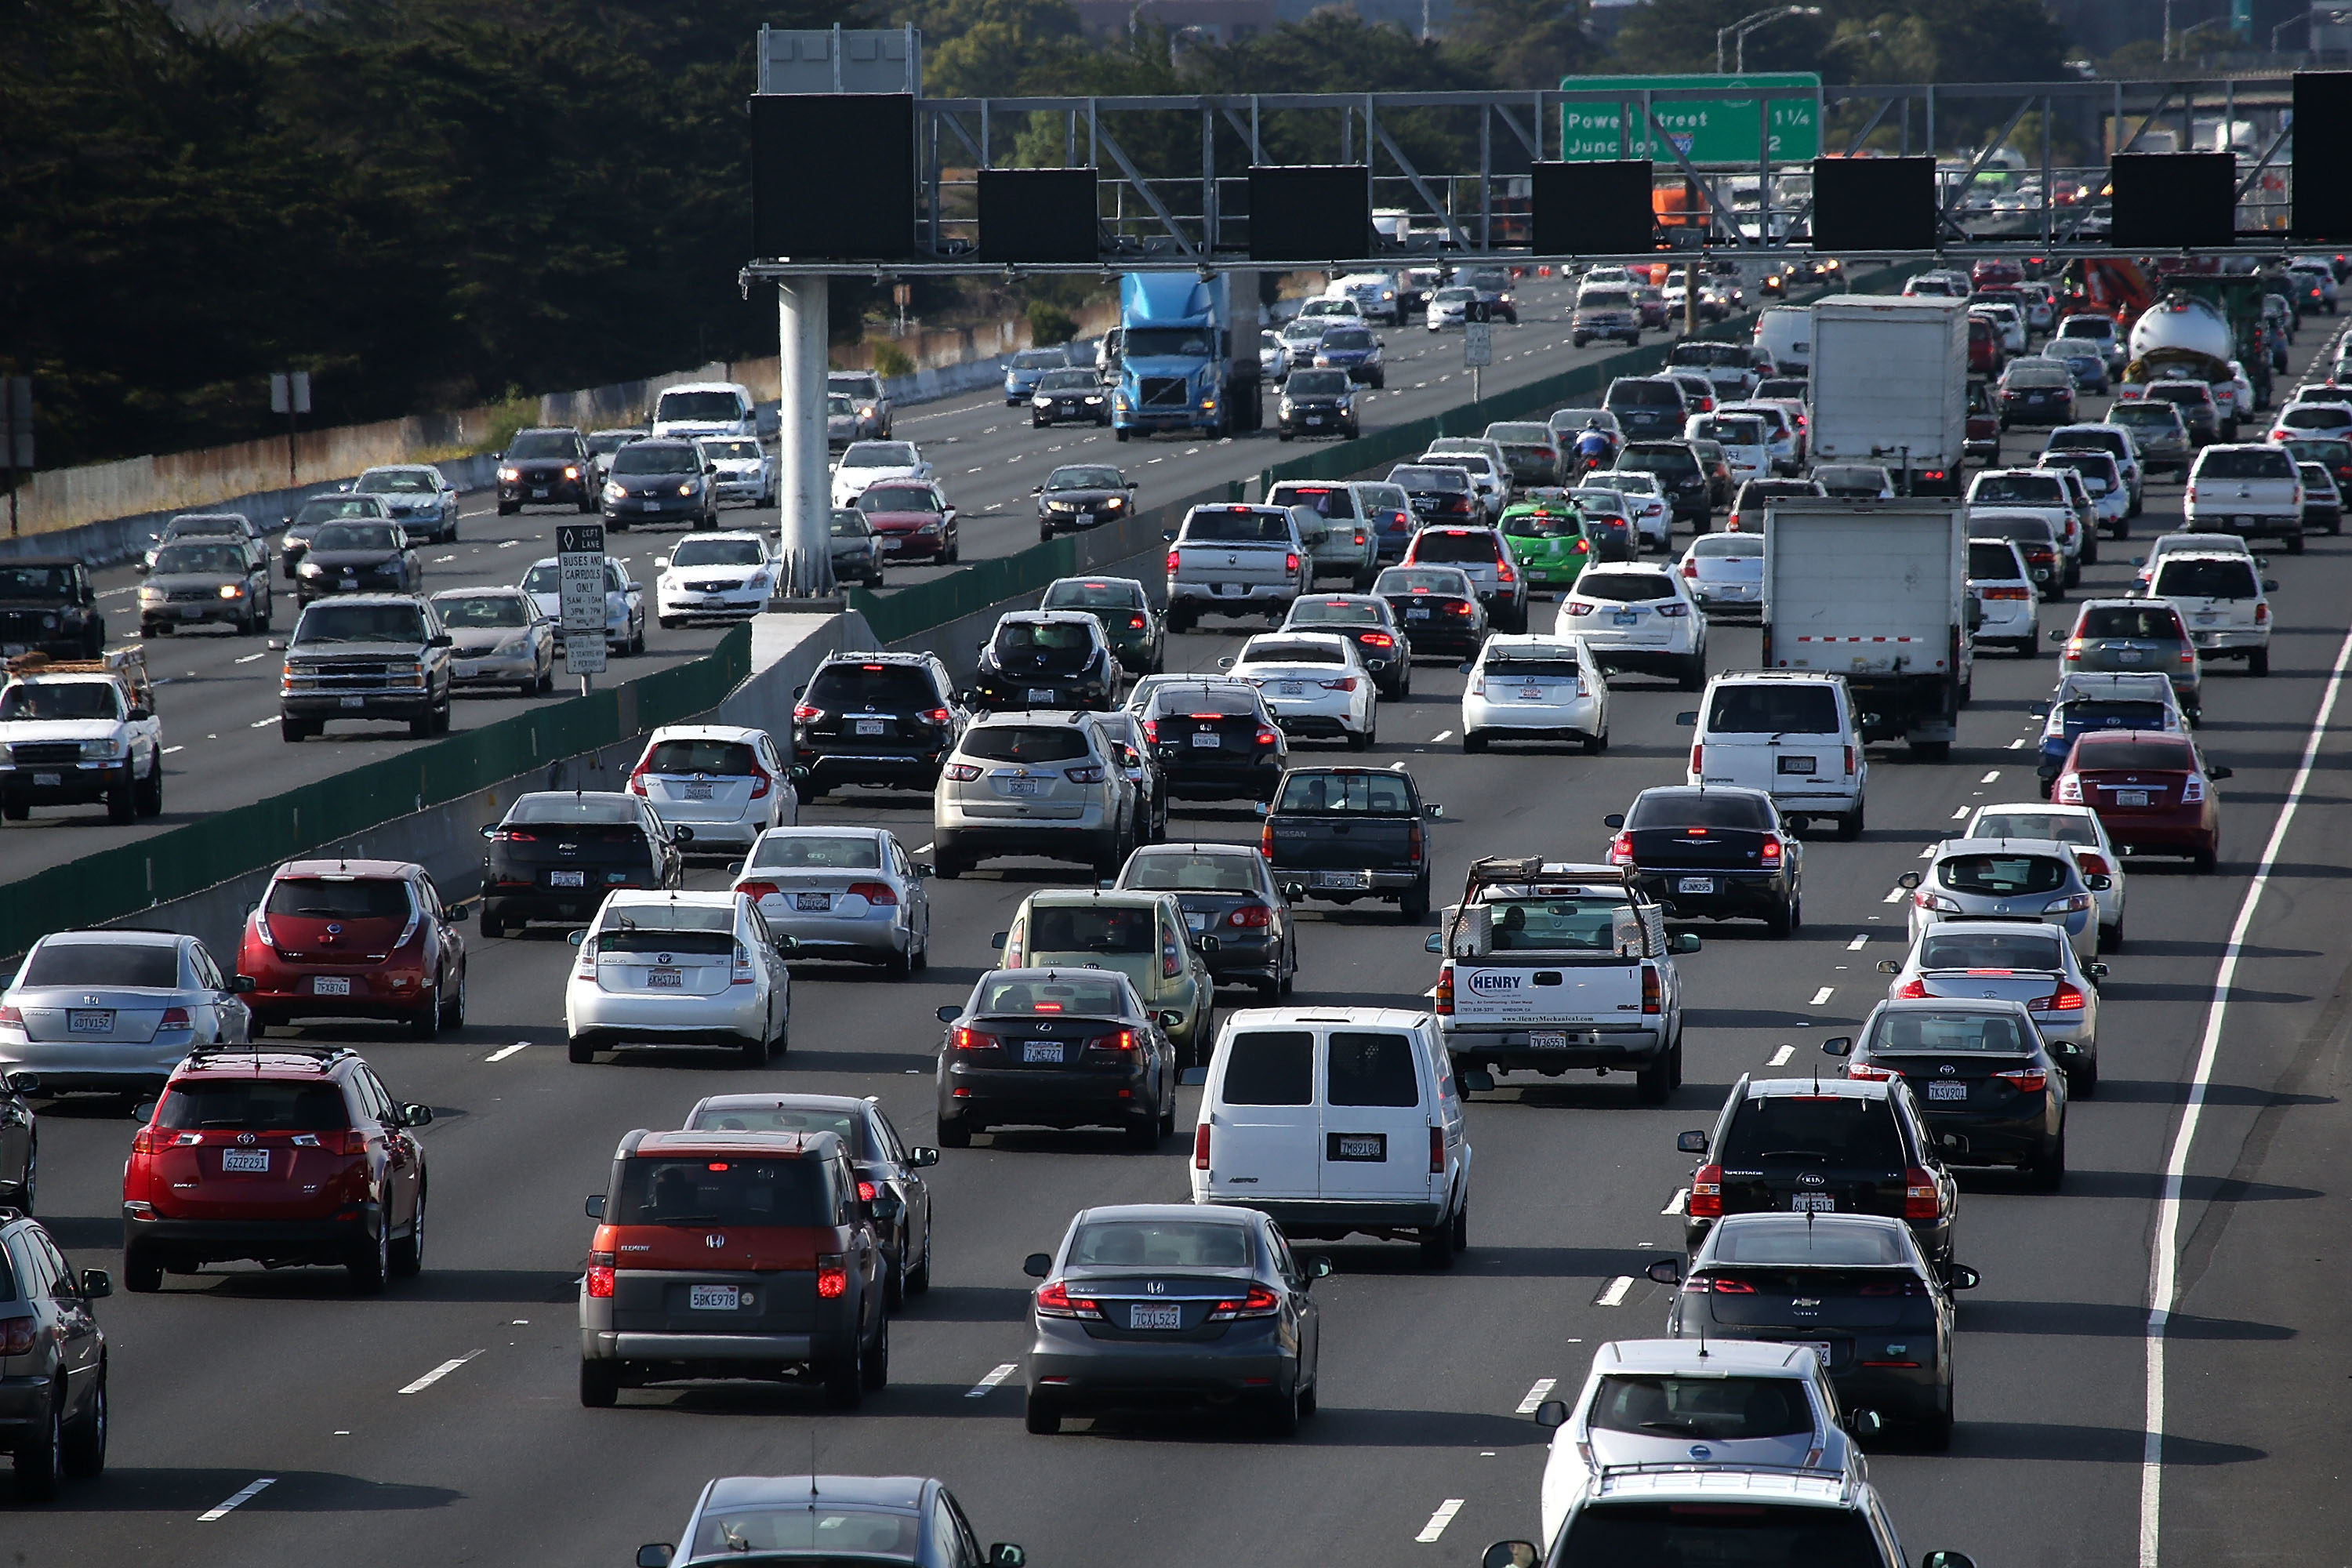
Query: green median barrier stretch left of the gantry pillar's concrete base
0,626,750,952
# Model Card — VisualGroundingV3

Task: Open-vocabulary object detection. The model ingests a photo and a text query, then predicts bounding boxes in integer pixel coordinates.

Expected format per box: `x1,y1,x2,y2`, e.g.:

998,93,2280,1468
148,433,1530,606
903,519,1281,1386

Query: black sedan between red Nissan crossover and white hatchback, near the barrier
482,789,694,935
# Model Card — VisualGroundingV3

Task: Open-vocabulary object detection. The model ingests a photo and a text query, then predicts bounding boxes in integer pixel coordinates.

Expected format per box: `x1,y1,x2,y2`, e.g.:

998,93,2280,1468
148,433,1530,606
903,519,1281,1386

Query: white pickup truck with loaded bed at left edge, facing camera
0,649,162,822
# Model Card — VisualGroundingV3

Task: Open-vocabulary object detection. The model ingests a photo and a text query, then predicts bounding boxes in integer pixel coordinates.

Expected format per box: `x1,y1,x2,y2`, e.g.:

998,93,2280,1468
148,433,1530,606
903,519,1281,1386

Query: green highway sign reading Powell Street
1559,71,1820,167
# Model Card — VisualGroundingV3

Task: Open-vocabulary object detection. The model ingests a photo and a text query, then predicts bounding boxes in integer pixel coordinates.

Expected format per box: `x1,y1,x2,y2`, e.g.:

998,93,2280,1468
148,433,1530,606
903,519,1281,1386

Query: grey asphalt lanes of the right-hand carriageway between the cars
0,327,2352,1568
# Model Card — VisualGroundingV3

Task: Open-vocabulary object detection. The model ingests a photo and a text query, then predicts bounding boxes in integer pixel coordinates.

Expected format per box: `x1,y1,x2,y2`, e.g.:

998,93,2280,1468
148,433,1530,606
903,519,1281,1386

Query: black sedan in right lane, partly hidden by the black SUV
1820,996,2065,1192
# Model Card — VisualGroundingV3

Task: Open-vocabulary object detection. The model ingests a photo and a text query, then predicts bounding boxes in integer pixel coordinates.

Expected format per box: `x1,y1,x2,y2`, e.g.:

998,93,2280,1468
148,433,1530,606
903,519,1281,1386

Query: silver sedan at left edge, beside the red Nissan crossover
0,931,254,1093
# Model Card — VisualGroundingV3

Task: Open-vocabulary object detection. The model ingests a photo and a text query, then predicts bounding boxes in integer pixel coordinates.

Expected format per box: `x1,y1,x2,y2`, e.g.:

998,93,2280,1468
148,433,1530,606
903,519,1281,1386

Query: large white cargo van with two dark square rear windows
1192,1008,1470,1269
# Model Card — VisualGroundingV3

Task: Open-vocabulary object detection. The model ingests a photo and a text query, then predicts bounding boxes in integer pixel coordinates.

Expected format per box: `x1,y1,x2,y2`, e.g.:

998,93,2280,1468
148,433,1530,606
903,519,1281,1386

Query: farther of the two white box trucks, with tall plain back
1811,294,1969,496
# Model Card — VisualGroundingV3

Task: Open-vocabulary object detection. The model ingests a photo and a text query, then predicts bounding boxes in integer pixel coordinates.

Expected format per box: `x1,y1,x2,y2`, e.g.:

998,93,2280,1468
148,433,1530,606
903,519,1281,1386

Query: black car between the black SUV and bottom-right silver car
1649,1213,1976,1450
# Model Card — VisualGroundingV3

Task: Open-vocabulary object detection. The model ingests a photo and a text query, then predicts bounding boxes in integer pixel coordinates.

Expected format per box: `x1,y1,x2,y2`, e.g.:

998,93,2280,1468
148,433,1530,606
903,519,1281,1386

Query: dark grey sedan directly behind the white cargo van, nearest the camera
1023,1203,1331,1436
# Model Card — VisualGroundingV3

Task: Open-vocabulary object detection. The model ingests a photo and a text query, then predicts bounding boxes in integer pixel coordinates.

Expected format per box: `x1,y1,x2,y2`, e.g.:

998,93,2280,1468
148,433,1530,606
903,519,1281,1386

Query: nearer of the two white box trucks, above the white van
1764,496,1978,762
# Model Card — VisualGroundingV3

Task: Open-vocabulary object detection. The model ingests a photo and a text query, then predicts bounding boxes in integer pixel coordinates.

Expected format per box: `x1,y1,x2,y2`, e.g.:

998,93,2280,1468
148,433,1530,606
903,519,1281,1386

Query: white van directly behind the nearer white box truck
1682,670,1870,839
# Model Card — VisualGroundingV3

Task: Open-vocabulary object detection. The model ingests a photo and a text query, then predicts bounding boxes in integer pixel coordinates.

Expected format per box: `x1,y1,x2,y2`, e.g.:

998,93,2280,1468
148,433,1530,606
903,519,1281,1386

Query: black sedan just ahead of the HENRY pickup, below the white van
1602,785,1804,935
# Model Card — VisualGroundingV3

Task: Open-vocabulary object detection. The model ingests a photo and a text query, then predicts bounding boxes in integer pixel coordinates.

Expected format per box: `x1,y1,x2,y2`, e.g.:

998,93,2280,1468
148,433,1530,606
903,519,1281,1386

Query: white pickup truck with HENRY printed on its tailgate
1428,858,1698,1105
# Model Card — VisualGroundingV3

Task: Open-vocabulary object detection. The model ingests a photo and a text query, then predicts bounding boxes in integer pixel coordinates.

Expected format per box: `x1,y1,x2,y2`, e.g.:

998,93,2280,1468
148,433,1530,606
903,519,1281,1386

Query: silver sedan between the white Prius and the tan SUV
734,827,931,975
